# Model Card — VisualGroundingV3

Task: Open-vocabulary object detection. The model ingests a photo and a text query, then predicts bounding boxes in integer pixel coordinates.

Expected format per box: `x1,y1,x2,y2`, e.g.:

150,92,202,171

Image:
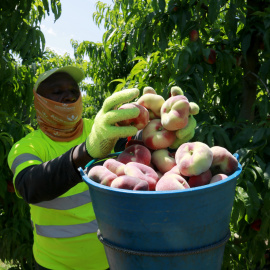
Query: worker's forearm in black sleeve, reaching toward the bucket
15,144,91,203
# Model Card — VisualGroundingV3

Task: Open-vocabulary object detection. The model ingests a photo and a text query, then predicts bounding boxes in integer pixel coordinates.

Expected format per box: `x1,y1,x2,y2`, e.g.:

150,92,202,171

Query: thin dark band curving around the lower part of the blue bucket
97,230,231,257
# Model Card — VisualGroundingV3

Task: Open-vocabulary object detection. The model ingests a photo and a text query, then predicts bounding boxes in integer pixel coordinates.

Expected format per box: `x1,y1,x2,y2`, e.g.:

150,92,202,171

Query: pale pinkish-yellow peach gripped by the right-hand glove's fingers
160,95,189,131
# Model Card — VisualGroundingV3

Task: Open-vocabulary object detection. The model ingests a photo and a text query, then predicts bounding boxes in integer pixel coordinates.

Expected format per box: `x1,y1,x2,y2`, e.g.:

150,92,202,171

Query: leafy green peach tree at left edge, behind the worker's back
0,0,61,269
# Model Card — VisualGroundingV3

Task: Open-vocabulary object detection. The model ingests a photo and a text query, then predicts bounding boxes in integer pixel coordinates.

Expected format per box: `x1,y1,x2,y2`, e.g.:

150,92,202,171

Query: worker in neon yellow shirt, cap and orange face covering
8,66,139,270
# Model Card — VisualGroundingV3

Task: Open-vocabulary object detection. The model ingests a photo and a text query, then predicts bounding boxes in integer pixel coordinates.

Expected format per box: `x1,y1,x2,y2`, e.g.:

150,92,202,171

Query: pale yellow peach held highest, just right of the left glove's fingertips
137,93,165,120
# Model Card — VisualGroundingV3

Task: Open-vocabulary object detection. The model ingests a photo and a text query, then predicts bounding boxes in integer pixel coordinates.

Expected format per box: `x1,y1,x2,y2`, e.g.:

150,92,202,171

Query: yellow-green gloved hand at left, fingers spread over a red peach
86,88,140,158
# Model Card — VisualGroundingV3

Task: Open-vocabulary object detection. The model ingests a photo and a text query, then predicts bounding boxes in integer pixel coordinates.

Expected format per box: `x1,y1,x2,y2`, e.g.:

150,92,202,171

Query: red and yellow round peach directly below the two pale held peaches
142,119,176,150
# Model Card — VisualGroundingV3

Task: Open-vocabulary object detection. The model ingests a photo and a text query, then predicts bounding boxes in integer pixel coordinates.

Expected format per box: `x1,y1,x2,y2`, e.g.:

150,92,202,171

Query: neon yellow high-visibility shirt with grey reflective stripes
8,119,109,270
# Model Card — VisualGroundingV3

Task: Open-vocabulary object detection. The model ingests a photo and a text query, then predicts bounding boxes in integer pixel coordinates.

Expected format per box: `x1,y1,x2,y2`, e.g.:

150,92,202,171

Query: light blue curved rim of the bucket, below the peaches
78,153,242,195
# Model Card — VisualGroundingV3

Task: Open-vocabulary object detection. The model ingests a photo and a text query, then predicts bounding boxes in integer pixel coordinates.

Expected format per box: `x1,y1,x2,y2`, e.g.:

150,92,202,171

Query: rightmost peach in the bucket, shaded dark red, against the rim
210,146,238,175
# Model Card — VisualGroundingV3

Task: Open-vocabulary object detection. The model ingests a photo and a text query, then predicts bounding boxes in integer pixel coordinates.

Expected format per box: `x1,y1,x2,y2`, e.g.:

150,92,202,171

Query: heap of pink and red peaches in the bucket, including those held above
88,86,238,191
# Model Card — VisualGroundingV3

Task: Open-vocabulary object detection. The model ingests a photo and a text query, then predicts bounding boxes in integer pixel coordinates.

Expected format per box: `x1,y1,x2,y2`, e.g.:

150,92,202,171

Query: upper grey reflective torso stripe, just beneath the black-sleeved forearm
33,190,91,210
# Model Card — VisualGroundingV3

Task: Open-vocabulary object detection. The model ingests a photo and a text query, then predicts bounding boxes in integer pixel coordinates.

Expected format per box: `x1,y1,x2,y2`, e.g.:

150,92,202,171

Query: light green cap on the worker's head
34,66,85,91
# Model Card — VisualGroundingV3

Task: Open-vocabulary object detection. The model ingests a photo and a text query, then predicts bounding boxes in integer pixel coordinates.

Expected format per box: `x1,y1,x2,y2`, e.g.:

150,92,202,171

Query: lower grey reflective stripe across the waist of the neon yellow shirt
35,219,98,238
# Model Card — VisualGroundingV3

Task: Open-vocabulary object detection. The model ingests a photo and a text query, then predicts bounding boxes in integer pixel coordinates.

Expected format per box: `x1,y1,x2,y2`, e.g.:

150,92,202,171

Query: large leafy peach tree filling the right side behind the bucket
73,0,270,269
